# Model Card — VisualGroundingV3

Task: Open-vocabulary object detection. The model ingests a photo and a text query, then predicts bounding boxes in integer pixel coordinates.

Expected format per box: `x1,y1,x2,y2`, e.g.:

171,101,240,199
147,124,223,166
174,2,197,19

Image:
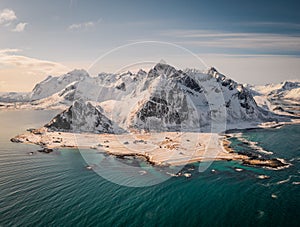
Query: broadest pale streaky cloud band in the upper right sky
162,30,300,51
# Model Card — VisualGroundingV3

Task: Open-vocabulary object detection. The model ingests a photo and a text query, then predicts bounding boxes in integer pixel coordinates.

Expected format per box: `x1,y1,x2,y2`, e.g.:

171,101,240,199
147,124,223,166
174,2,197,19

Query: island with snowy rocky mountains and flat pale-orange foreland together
11,63,298,169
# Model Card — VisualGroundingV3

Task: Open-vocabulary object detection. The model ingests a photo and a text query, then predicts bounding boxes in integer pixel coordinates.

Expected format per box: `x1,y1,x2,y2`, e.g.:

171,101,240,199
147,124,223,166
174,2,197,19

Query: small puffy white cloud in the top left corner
0,9,28,32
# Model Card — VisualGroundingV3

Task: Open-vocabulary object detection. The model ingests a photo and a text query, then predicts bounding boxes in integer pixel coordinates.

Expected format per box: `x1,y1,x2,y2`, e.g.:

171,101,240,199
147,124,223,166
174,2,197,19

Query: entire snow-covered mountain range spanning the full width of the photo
0,63,300,133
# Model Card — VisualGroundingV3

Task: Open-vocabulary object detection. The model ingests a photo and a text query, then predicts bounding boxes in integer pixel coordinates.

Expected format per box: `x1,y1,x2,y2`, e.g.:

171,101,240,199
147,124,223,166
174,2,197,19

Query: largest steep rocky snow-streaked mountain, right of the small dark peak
129,64,272,130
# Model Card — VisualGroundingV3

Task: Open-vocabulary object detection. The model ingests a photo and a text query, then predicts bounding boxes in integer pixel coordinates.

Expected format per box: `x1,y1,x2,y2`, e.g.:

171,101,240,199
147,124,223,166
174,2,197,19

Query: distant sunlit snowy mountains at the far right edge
248,81,300,116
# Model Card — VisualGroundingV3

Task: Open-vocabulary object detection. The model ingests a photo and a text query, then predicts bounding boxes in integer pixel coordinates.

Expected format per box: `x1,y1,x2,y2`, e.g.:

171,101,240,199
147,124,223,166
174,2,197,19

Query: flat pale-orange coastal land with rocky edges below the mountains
11,127,288,169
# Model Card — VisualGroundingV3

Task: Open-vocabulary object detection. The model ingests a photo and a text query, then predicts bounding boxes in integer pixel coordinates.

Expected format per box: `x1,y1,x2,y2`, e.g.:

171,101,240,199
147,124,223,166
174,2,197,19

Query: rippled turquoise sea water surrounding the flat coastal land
0,111,300,226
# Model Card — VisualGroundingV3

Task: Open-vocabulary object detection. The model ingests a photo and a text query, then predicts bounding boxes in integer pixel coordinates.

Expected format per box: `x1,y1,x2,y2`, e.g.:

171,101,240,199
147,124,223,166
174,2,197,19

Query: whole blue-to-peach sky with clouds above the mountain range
0,0,300,92
